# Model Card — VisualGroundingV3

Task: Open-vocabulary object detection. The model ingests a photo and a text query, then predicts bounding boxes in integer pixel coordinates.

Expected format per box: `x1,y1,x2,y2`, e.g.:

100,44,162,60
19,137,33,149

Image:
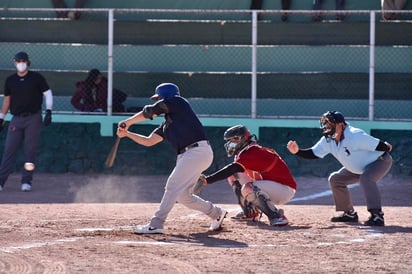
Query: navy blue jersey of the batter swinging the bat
154,96,208,151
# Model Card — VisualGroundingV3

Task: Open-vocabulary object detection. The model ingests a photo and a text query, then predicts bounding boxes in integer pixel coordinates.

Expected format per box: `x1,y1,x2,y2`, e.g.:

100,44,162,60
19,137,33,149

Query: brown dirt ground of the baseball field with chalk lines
0,174,412,274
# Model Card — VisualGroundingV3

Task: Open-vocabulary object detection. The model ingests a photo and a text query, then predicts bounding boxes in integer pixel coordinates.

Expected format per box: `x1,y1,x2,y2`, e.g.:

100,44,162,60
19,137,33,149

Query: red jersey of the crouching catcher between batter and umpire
235,144,296,189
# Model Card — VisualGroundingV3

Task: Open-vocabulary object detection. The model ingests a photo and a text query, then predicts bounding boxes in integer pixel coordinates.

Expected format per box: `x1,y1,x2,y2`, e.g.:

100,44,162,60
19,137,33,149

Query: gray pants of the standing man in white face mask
0,111,43,185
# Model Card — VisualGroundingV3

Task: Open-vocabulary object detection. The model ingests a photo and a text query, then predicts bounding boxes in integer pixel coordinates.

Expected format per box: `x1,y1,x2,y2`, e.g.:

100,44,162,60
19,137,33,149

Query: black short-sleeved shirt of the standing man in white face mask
4,71,50,115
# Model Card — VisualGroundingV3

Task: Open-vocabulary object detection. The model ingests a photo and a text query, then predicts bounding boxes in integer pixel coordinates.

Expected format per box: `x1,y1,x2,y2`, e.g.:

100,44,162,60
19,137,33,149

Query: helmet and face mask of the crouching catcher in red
223,125,256,157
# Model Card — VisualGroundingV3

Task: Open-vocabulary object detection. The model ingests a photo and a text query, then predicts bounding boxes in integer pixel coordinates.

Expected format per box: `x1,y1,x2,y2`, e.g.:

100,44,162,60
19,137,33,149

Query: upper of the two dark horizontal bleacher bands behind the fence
0,18,412,46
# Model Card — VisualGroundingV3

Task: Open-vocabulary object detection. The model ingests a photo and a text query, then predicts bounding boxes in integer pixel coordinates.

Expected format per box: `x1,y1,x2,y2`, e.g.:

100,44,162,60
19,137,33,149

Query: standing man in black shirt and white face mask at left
0,52,53,191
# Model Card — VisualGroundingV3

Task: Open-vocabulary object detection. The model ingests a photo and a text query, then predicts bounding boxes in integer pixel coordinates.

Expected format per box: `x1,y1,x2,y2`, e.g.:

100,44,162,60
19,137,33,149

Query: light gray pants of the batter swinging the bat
150,141,221,228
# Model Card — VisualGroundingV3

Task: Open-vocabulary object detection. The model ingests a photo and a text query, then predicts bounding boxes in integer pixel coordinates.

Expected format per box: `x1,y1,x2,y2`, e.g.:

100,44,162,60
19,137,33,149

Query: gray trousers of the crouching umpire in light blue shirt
328,152,392,211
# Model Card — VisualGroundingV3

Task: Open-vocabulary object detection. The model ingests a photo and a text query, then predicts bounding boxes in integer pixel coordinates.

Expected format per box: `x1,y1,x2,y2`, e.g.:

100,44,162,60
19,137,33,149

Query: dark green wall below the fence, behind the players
0,123,412,177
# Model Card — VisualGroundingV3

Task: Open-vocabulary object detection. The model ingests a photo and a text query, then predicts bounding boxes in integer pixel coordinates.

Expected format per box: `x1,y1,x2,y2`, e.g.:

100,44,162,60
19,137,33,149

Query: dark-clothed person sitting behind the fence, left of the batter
71,68,127,112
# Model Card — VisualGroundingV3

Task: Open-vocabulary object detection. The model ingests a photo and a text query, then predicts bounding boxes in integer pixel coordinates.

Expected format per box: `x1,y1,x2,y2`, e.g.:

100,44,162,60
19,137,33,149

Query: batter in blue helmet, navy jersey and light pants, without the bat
117,83,227,234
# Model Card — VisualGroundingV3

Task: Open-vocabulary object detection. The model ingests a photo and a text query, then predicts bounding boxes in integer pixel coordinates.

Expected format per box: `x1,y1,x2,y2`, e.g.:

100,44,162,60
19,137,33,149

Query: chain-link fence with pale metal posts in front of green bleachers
0,9,412,120
